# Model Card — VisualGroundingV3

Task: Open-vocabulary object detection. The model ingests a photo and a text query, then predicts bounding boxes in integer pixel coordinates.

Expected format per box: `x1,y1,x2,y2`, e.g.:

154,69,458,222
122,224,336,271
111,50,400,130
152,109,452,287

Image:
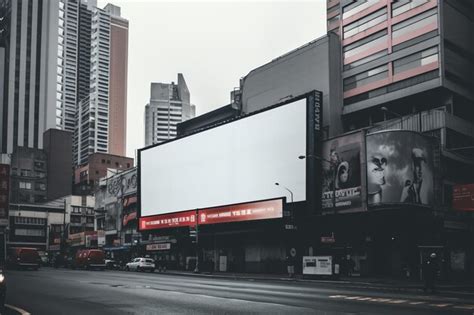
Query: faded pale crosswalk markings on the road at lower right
329,294,474,311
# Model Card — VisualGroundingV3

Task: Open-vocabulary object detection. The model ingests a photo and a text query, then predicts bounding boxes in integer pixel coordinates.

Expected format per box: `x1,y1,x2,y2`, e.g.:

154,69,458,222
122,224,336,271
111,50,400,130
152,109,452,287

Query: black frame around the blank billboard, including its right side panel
137,90,323,232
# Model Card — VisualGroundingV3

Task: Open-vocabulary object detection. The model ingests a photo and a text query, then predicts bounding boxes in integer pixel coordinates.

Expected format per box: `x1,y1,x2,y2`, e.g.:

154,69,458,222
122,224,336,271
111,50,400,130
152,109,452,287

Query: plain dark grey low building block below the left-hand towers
43,129,72,200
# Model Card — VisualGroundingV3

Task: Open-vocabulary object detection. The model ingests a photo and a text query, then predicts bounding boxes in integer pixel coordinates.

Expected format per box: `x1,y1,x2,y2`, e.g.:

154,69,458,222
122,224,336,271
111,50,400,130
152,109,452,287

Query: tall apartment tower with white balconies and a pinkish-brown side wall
74,4,128,165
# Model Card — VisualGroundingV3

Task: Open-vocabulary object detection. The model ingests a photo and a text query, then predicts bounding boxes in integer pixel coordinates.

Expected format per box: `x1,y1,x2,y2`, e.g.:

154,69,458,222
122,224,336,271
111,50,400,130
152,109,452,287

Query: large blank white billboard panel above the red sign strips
139,99,306,217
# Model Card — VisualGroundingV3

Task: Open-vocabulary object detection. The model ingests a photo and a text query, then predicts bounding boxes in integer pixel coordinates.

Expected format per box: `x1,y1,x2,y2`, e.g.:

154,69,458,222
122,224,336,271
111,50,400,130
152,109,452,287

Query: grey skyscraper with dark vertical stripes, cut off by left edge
0,0,70,153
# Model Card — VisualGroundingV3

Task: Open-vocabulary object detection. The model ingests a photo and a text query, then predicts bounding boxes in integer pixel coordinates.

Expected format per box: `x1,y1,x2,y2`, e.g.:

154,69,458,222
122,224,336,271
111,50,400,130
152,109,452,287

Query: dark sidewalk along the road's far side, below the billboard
159,270,474,299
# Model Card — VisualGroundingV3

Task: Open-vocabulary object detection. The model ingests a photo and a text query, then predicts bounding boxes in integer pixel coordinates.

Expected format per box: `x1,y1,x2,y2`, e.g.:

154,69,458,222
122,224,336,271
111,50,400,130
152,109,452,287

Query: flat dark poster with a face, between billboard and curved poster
322,133,362,210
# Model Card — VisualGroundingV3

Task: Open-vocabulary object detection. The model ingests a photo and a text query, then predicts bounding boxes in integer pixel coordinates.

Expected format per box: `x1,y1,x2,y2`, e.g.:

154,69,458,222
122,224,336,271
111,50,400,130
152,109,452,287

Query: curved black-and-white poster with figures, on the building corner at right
366,131,433,205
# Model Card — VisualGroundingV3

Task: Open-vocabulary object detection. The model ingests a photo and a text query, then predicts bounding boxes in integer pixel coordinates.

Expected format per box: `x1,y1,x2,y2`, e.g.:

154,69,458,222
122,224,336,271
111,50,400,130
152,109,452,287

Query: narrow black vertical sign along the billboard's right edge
306,91,323,216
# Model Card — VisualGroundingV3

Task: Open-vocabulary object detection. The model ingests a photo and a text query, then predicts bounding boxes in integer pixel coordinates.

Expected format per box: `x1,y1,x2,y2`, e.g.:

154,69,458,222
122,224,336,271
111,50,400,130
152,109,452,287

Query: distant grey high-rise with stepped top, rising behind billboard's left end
145,73,196,146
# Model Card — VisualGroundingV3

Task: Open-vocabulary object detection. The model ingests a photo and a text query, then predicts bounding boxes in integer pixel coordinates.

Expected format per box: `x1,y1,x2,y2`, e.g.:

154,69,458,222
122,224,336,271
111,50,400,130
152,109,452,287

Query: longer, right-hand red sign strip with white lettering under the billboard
199,199,283,224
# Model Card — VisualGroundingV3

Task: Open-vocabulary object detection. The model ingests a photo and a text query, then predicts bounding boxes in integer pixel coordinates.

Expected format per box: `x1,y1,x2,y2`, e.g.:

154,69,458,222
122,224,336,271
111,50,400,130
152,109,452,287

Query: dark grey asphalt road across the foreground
6,268,474,315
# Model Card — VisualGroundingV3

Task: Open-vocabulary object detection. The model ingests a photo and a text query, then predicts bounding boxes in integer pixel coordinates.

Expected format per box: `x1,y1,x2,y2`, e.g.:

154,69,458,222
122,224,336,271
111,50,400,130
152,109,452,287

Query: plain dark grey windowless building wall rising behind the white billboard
241,33,342,136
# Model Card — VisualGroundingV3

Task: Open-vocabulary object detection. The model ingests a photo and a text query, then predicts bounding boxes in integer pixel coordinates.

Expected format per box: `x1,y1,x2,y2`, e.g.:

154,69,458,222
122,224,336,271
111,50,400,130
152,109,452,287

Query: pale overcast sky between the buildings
98,0,326,157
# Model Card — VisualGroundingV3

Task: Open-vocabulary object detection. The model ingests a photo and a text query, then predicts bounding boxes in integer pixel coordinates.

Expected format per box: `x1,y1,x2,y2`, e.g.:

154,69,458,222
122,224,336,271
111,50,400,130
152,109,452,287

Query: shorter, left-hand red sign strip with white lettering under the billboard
140,211,196,231
